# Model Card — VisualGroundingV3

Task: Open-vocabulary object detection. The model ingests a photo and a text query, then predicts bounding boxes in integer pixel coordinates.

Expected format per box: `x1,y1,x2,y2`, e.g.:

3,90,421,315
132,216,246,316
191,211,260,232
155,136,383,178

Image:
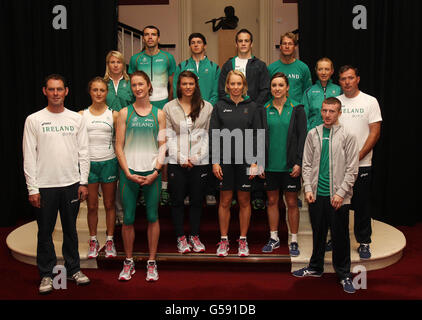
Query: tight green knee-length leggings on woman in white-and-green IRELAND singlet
119,169,161,226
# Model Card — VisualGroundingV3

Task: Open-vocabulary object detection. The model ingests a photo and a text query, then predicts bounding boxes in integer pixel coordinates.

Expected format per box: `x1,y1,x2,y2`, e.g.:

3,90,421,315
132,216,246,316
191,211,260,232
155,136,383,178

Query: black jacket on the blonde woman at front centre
209,96,262,164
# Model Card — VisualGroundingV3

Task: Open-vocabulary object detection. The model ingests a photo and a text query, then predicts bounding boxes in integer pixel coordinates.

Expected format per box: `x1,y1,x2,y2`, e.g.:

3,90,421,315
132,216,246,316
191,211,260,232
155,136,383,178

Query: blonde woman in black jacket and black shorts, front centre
209,70,261,257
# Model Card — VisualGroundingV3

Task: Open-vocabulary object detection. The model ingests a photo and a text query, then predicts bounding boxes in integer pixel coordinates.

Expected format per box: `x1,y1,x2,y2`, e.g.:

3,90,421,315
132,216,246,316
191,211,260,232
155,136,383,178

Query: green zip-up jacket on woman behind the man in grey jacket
302,80,342,131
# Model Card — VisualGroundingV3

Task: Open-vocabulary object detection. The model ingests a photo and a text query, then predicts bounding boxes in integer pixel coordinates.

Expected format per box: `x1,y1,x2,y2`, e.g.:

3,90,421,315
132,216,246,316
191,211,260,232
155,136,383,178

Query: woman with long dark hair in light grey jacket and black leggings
163,71,212,253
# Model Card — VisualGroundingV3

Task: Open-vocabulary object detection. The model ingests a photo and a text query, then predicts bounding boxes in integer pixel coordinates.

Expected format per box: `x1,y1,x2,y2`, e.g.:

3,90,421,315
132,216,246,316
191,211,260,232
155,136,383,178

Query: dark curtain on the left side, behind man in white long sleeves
0,0,117,226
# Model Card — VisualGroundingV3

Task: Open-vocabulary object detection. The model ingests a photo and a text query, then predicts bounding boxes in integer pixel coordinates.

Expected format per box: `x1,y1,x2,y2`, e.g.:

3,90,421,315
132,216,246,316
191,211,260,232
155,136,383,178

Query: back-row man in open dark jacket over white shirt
218,29,270,107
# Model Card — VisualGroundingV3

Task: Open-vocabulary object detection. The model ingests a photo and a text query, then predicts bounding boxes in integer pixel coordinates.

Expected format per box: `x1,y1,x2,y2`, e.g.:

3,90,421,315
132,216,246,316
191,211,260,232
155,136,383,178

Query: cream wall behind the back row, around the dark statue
119,0,299,63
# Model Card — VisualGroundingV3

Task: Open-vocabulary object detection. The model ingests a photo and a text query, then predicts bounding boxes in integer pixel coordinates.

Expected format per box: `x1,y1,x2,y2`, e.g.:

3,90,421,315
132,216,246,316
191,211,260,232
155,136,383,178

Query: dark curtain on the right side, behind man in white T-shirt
299,0,422,225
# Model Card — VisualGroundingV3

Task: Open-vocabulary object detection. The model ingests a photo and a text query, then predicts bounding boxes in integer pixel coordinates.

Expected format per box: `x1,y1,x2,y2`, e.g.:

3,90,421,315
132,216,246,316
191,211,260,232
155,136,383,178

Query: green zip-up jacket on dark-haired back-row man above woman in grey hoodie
173,57,221,105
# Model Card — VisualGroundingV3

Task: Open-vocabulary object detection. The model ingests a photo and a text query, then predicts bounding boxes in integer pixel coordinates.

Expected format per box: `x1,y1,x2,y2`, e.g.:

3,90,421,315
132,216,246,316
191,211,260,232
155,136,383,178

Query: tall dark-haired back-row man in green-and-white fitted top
128,26,176,205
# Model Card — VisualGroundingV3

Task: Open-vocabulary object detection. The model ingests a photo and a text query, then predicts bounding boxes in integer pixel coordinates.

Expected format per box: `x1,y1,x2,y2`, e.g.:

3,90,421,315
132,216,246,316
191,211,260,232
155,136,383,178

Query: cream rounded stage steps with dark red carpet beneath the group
6,195,406,273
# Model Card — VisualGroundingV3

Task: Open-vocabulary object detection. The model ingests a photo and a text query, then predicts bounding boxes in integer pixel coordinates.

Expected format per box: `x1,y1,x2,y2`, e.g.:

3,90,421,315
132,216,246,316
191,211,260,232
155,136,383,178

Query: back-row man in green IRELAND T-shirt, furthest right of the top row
268,32,312,103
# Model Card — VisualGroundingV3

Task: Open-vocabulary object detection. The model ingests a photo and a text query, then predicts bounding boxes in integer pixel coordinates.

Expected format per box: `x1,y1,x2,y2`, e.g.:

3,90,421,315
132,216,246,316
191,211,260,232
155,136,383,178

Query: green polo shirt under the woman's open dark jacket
265,98,294,172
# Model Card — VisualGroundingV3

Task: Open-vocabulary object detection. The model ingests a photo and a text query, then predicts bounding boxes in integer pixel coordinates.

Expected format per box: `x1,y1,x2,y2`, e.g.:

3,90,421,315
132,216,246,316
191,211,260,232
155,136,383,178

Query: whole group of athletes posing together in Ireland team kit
23,26,382,293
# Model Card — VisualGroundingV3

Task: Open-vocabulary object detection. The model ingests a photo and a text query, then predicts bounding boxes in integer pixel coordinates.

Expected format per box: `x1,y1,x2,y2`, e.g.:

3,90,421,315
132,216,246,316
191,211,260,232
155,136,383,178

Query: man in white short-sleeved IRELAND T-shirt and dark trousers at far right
338,65,382,259
